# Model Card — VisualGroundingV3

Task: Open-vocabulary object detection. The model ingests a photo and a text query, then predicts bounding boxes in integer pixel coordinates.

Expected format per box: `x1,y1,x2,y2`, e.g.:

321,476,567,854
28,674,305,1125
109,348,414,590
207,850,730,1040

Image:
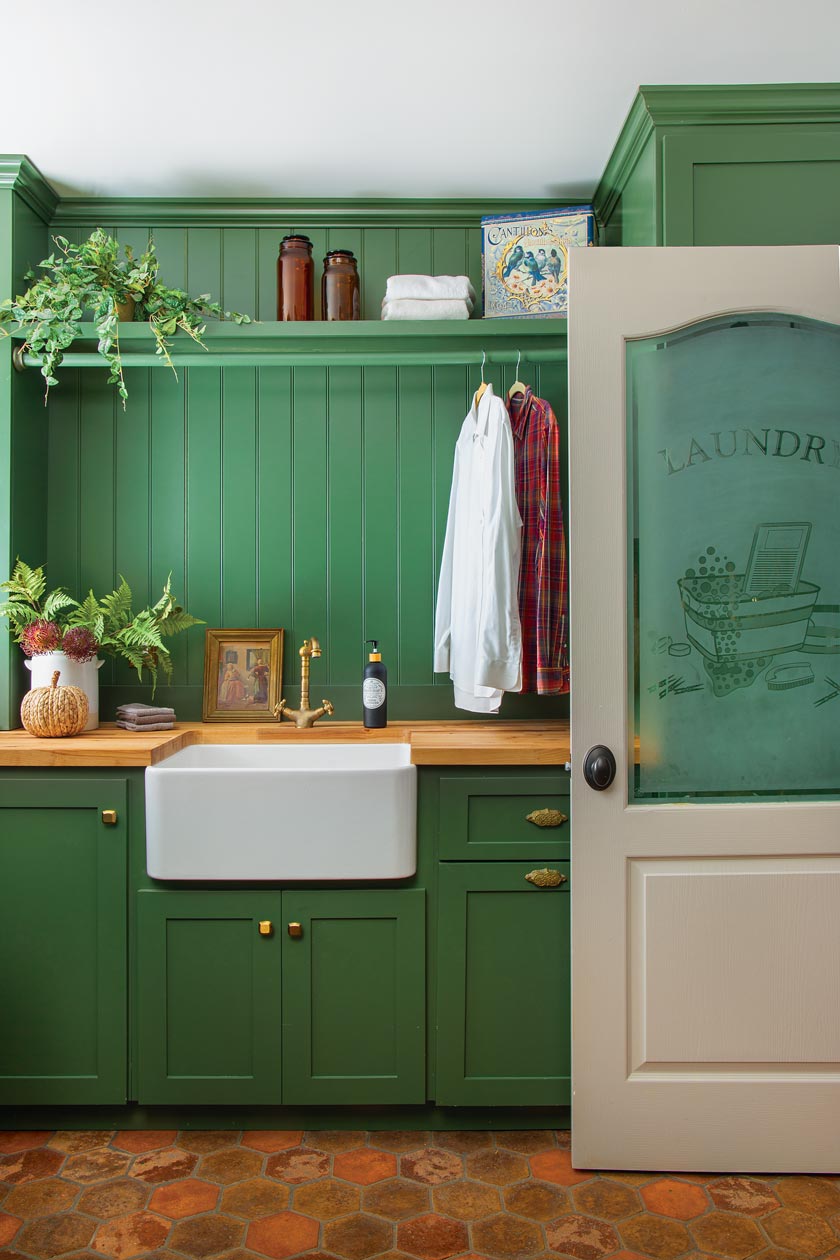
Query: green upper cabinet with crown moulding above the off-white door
594,83,840,246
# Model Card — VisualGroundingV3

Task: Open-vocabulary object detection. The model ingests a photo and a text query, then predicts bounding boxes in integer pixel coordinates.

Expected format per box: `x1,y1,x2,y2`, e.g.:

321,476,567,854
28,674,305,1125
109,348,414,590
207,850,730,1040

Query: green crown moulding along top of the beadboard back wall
53,197,581,229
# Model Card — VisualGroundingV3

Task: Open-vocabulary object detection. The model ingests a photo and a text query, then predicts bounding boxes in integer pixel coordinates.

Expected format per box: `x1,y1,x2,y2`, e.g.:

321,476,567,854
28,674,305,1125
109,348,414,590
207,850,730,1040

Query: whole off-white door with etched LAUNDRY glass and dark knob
569,246,840,1173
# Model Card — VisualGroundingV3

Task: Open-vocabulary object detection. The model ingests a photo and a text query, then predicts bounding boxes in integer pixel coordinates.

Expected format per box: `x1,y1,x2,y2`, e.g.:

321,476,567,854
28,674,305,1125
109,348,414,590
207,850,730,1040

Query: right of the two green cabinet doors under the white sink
283,888,426,1103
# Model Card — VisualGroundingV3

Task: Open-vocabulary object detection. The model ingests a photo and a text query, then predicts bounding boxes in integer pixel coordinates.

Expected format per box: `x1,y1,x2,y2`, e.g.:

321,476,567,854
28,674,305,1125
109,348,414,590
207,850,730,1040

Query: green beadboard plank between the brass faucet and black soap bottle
327,368,365,690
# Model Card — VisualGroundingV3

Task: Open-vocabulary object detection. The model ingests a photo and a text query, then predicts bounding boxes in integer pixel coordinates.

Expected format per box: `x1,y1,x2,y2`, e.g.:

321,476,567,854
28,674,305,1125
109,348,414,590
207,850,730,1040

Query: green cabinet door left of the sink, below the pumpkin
0,779,127,1104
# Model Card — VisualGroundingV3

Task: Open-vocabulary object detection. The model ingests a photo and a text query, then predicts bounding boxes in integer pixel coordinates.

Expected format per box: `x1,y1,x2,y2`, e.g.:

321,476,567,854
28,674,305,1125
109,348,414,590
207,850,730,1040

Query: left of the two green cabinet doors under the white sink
136,890,282,1104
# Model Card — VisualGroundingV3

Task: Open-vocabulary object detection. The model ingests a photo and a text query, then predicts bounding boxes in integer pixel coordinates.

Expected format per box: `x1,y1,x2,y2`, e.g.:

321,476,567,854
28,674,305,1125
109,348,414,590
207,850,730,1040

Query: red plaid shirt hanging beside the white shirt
508,389,569,696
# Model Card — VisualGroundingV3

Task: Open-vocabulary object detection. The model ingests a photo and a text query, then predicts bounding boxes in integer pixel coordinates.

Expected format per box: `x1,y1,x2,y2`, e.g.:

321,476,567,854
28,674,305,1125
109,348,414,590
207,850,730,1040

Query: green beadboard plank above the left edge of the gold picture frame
185,368,221,687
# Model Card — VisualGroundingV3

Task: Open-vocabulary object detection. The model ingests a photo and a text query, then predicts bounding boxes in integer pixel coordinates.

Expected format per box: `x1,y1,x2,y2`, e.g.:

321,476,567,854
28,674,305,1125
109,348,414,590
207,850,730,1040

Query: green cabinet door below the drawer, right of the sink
436,861,570,1106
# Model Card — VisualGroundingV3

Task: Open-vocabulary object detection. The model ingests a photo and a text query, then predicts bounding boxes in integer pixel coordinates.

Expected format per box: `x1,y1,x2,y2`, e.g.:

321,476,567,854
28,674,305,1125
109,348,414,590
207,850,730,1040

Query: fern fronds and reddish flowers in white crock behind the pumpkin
0,559,204,696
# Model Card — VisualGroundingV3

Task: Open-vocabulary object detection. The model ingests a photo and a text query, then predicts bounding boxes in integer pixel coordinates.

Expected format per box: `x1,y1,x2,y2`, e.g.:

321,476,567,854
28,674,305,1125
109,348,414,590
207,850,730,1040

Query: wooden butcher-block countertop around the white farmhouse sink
0,719,569,767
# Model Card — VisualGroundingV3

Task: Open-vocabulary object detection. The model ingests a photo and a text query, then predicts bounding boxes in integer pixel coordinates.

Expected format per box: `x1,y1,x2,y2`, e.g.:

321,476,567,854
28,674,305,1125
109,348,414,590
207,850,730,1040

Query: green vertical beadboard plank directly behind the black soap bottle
364,368,400,685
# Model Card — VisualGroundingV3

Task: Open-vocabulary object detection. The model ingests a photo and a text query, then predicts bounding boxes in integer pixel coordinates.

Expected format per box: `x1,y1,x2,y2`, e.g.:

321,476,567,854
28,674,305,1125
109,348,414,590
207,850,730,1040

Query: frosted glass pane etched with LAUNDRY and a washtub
626,314,840,803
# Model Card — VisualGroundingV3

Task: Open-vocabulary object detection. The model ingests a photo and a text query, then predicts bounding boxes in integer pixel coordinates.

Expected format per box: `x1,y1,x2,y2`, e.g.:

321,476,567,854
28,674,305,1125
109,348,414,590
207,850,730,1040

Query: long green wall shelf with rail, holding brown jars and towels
16,316,567,368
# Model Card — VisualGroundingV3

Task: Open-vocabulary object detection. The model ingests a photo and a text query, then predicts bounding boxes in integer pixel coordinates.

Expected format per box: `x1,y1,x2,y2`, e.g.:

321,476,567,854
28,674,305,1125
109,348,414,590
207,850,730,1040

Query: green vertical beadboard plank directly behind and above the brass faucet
290,368,330,680
